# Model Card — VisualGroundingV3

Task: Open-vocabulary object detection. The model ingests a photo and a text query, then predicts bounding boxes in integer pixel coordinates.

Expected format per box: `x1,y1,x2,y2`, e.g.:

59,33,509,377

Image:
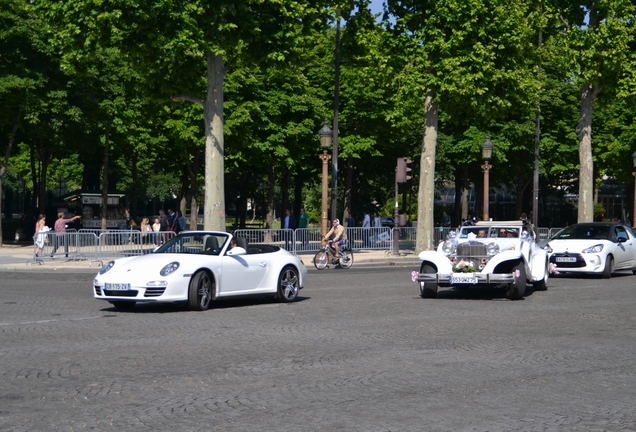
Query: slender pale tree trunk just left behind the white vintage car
415,88,439,251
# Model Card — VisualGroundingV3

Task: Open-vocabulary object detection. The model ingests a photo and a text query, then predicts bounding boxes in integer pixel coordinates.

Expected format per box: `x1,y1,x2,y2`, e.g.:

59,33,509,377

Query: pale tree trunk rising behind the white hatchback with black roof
577,83,599,223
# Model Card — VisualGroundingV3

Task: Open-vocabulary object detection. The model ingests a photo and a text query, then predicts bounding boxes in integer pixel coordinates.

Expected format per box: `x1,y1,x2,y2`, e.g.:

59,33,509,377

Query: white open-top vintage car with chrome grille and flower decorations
415,220,550,300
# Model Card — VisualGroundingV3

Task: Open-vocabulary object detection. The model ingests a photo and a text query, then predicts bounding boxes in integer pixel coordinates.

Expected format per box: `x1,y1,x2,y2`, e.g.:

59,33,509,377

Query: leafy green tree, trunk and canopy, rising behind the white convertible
43,0,328,230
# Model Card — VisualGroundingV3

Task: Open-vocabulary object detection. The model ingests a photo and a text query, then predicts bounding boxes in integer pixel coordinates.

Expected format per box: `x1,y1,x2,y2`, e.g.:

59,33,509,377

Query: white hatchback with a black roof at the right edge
545,222,636,278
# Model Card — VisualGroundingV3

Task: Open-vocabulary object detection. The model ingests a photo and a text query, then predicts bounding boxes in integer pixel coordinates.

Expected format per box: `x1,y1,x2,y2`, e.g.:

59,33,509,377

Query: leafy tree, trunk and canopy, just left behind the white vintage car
388,0,535,250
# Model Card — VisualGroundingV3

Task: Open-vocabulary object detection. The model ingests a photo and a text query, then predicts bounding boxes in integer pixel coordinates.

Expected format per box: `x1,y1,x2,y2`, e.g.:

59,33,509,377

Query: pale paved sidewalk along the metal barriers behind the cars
0,244,420,272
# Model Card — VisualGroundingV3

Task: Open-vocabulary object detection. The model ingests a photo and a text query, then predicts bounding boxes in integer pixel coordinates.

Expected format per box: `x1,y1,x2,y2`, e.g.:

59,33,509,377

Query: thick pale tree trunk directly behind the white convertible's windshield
204,52,226,231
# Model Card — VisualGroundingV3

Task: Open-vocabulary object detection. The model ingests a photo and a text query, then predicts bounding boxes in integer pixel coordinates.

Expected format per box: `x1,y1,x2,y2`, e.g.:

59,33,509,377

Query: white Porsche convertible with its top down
93,231,307,311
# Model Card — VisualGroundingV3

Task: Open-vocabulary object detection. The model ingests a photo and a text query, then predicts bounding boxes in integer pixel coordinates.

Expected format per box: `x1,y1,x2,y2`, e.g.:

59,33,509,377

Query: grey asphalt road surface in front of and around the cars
0,267,636,431
